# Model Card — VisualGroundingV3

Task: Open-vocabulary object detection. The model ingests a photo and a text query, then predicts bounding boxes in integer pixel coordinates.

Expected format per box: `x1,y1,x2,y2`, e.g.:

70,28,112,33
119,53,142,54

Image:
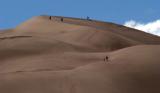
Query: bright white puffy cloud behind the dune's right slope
124,19,160,36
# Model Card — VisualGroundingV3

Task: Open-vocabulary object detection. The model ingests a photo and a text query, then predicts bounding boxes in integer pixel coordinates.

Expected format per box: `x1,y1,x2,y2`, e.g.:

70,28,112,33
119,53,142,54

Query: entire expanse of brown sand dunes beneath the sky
0,16,160,93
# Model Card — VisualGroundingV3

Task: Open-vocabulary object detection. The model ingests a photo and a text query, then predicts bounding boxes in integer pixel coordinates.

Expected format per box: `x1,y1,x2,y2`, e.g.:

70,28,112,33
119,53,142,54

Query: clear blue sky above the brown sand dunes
0,0,160,29
